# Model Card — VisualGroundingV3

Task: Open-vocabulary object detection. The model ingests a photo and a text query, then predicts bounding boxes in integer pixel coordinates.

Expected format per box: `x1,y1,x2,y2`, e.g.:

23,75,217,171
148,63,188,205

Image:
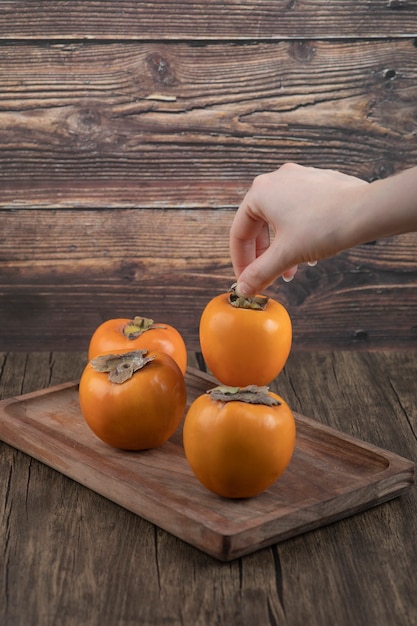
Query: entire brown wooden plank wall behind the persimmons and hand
0,0,417,350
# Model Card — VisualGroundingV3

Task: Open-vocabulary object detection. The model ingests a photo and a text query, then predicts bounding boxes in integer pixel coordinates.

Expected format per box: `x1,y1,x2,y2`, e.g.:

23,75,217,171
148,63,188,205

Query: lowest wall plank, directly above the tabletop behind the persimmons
0,209,417,350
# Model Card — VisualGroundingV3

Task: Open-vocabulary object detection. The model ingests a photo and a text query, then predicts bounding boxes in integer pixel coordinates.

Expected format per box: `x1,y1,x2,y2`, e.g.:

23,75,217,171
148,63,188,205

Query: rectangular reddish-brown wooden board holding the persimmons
0,368,414,561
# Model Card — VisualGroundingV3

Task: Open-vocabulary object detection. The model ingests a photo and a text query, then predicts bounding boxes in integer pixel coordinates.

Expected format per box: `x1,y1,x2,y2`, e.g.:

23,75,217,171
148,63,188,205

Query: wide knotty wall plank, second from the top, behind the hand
0,39,417,208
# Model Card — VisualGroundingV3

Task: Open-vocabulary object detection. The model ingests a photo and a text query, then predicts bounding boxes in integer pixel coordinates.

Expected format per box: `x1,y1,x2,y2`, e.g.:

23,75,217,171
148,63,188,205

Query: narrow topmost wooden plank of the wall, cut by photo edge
0,0,417,40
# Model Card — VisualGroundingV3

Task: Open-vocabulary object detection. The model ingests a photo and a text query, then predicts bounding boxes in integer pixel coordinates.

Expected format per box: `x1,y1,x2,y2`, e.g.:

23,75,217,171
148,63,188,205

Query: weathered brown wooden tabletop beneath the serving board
0,351,417,626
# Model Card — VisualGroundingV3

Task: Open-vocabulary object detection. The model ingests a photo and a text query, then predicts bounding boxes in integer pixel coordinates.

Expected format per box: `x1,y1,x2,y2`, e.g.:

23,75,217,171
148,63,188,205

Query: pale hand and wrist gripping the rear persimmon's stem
230,163,417,296
